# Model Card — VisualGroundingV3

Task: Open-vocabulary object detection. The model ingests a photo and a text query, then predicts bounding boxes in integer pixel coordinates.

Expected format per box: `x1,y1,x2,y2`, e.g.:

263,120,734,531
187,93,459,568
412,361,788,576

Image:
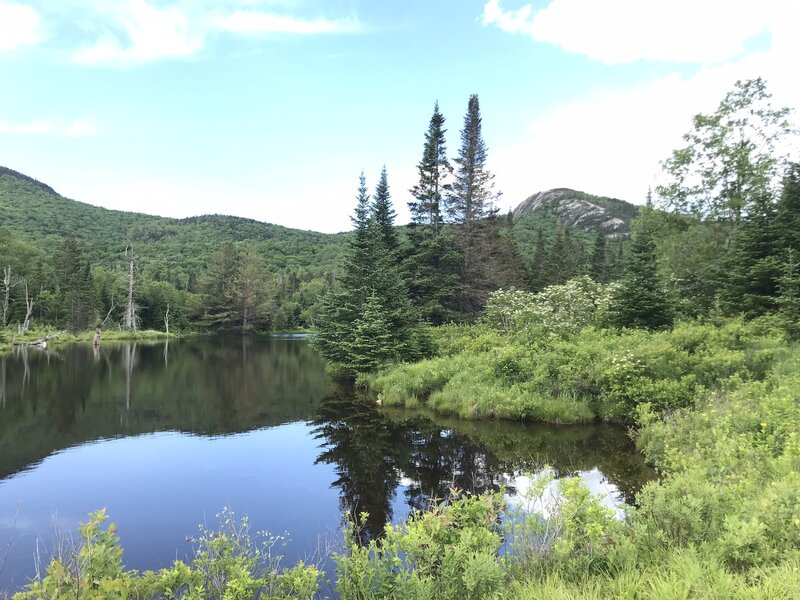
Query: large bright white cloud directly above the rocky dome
487,0,800,208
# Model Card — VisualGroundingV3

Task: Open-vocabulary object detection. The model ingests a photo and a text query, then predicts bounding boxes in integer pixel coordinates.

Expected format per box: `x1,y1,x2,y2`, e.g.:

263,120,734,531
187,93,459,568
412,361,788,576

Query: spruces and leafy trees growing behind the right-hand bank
316,79,800,374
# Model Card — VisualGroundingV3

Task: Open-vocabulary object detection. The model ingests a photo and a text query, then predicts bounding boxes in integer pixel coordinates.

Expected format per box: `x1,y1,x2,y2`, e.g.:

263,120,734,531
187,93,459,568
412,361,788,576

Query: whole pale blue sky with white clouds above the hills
0,0,800,232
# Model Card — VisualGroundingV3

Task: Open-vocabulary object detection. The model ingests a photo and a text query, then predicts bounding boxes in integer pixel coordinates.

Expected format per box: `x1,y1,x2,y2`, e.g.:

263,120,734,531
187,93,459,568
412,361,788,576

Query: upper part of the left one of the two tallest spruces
408,102,453,237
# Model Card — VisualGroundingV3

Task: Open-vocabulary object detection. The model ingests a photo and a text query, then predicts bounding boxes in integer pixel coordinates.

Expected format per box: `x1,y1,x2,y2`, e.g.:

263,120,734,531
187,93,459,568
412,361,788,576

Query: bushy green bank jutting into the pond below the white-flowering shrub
360,320,786,423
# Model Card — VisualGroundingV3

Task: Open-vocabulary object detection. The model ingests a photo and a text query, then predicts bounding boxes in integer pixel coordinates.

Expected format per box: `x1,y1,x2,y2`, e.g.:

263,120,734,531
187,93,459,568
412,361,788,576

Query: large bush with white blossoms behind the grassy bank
484,276,619,333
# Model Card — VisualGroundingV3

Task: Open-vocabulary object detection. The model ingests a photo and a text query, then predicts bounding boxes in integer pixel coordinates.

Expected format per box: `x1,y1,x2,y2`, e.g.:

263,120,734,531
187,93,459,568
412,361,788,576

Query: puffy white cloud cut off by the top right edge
482,0,776,64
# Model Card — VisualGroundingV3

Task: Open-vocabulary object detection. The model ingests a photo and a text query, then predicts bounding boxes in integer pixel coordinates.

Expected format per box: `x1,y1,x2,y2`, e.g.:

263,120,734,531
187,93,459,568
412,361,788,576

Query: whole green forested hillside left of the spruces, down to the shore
0,168,344,330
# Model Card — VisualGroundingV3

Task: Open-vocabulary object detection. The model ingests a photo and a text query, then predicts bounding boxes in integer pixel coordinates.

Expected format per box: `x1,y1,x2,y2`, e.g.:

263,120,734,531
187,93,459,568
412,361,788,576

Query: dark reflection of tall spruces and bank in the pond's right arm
314,390,654,541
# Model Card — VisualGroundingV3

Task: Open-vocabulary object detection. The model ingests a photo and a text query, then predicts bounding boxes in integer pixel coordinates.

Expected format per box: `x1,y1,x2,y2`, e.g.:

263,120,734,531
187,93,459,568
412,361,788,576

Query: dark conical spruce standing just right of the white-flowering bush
610,208,672,329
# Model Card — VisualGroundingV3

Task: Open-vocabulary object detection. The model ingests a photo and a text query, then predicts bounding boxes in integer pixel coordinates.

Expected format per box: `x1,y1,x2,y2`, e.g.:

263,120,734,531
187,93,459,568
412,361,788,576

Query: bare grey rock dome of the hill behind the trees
514,188,639,239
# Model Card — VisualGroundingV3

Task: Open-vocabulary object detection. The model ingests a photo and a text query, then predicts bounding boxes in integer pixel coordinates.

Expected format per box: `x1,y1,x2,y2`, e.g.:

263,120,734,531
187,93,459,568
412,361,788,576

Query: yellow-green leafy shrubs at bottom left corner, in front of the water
14,510,321,600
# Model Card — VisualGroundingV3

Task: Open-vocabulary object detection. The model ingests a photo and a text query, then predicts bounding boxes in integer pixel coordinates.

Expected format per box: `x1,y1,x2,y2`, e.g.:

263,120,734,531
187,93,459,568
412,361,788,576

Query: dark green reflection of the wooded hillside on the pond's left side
0,337,330,479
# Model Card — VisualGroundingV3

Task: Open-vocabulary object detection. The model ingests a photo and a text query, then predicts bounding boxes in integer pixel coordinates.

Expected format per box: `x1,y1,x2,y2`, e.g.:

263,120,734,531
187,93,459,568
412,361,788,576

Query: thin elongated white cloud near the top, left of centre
217,11,361,35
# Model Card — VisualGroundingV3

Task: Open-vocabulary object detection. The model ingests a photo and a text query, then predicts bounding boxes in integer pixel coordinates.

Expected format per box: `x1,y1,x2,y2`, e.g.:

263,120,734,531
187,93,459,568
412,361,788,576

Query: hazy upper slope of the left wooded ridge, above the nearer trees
0,167,343,276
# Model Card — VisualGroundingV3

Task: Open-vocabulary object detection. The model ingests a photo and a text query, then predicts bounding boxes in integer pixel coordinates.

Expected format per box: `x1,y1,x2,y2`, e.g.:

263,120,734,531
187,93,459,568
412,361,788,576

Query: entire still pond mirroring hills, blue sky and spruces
0,337,652,590
